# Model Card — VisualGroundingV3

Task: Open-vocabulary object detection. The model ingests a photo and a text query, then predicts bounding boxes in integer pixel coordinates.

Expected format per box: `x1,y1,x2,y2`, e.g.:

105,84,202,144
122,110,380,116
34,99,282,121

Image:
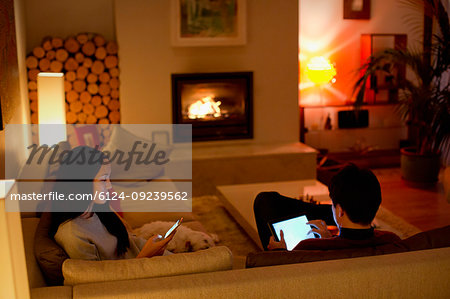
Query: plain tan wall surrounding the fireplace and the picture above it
115,0,299,143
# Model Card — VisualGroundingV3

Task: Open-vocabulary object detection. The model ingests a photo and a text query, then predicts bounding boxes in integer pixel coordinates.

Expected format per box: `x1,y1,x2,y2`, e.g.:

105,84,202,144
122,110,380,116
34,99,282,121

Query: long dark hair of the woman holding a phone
49,146,130,256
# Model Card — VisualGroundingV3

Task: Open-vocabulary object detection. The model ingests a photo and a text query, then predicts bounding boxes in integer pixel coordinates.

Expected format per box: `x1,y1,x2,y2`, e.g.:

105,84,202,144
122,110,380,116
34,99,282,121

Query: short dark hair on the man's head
328,164,381,225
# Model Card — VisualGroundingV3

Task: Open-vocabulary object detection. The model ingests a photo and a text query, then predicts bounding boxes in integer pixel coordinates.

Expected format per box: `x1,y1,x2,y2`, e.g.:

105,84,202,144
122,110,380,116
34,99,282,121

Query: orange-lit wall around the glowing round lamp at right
299,0,423,152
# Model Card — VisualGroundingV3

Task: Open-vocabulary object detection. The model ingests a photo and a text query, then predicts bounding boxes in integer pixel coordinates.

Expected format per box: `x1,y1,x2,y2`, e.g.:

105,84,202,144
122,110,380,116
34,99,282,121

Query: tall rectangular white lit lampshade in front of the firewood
37,73,67,146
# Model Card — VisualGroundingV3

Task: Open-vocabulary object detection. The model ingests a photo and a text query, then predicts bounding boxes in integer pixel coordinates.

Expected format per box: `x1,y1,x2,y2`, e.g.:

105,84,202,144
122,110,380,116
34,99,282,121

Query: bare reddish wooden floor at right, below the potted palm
374,168,450,231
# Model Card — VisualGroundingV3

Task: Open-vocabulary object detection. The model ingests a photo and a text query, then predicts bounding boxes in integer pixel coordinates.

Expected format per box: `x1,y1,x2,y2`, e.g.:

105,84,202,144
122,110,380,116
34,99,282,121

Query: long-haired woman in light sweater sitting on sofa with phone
49,146,174,260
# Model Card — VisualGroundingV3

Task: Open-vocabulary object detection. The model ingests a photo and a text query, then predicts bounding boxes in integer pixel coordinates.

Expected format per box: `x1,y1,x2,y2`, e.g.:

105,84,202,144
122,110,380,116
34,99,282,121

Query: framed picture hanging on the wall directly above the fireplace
171,0,246,47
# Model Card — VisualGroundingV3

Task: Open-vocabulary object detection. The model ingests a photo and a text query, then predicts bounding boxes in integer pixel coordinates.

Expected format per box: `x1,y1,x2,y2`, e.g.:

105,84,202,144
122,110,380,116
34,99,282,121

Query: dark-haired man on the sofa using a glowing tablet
254,165,400,250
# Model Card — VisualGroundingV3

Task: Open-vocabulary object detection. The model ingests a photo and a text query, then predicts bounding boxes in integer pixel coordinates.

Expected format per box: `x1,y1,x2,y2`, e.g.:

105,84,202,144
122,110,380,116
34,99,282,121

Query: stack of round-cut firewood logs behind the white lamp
26,33,120,124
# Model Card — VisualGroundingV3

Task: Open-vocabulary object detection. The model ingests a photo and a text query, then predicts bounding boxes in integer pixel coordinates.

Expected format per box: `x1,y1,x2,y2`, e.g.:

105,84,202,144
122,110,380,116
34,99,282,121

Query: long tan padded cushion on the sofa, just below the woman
63,246,233,286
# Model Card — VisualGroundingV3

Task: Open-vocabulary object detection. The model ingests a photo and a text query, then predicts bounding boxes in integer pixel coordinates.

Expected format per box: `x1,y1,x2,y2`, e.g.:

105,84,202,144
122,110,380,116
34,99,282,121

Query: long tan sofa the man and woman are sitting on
22,213,450,299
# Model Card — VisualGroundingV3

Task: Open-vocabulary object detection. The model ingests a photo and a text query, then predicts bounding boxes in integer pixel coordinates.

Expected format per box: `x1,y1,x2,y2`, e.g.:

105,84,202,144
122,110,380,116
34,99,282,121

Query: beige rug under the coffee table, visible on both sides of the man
192,195,420,257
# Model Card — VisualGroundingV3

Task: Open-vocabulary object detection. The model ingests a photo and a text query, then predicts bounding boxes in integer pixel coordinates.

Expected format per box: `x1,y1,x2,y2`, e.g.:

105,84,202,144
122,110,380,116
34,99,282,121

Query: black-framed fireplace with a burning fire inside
172,72,253,142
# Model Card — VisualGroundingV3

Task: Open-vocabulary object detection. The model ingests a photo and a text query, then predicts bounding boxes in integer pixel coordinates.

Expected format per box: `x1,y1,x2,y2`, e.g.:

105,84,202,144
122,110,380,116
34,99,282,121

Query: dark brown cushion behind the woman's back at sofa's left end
34,212,69,286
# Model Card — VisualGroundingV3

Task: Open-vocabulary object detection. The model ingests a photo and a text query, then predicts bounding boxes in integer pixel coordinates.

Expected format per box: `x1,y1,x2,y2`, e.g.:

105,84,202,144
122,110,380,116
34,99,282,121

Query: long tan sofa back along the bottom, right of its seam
73,248,450,299
